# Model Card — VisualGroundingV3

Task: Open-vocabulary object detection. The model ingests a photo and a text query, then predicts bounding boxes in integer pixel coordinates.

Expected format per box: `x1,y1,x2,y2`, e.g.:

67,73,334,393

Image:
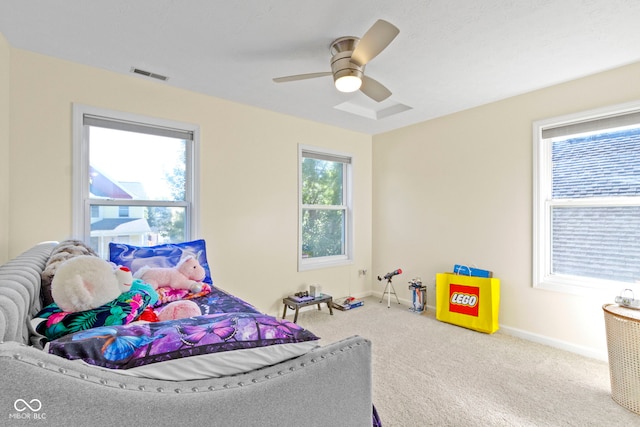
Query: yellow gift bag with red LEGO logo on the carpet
436,273,500,334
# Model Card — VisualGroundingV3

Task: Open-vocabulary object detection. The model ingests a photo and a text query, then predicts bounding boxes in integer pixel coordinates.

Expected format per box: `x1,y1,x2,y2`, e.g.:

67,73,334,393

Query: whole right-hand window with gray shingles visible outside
533,103,640,293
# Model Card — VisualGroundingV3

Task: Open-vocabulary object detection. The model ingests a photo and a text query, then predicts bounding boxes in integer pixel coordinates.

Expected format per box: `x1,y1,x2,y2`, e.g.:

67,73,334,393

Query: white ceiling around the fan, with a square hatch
0,0,640,134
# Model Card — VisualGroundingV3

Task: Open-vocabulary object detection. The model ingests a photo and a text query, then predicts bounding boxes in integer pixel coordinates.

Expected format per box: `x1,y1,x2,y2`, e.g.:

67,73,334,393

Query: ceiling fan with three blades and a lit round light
273,19,400,102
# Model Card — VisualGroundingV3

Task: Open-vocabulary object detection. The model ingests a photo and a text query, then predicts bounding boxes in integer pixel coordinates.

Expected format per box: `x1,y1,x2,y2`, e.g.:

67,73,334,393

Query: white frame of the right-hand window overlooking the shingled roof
532,101,640,295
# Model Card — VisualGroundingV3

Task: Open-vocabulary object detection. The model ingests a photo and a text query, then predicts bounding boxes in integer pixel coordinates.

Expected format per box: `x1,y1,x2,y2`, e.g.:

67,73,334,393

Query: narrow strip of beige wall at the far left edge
0,34,10,261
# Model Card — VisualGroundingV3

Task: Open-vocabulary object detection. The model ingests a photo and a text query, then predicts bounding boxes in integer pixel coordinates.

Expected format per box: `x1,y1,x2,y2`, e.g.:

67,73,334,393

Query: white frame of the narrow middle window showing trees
298,144,354,272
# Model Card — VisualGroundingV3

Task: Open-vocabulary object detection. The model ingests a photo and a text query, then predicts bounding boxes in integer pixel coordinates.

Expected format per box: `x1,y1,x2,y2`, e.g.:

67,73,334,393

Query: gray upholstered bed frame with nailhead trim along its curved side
0,242,372,427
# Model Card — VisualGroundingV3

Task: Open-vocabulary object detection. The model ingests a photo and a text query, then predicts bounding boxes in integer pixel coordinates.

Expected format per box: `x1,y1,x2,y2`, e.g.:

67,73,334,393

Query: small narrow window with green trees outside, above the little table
298,146,352,271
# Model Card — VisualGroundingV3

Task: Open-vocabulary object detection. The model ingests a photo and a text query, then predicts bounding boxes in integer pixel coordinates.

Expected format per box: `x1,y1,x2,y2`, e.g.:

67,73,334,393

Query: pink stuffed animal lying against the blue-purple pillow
134,256,206,292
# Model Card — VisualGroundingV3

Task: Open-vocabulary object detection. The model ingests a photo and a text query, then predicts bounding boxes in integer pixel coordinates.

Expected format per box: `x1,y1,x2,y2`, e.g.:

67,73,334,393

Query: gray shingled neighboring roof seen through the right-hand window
552,129,640,283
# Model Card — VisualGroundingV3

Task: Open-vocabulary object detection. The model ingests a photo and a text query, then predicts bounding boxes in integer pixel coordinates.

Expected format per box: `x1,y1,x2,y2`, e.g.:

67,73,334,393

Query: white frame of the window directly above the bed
71,104,200,249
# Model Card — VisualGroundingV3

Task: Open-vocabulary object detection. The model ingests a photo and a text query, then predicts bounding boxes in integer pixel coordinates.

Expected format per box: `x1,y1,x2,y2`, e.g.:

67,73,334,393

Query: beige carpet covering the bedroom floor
298,297,640,427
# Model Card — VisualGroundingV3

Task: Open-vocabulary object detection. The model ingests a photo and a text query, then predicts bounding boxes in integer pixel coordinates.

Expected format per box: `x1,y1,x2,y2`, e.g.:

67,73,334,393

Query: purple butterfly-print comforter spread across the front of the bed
48,287,319,369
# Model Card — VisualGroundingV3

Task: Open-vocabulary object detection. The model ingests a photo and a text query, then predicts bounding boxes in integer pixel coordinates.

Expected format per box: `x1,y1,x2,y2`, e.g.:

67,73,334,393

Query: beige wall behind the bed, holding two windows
5,49,372,313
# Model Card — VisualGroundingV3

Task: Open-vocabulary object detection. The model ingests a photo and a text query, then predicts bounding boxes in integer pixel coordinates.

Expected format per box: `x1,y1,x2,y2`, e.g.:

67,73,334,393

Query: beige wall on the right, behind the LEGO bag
373,64,640,357
